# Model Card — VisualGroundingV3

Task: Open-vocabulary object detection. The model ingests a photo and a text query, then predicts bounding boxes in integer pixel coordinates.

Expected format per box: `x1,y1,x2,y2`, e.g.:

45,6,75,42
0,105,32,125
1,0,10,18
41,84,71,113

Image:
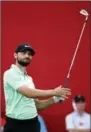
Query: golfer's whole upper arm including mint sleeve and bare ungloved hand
4,71,71,99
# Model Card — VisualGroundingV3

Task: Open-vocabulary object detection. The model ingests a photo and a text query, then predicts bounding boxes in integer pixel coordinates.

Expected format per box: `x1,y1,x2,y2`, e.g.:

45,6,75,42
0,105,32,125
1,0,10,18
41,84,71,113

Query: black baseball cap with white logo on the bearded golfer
15,43,35,56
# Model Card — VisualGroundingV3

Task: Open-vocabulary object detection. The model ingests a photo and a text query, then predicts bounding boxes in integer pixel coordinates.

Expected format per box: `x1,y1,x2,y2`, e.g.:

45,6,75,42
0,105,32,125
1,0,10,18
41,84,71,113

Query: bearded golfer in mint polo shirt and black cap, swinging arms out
3,43,71,132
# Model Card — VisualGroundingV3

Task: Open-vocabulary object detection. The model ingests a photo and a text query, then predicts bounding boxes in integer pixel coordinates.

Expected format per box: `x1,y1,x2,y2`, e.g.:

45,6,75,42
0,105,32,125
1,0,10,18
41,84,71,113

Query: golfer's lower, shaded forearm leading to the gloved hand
35,97,55,110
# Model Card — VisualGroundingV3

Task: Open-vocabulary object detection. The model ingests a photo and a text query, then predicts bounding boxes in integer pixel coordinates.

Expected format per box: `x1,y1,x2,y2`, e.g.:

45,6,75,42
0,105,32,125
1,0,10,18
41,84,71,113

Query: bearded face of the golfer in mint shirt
15,51,32,67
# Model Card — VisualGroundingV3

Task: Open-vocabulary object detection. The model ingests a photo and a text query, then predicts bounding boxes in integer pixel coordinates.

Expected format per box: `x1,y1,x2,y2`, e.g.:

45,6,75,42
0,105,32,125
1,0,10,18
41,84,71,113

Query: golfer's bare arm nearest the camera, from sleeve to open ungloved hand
17,85,71,99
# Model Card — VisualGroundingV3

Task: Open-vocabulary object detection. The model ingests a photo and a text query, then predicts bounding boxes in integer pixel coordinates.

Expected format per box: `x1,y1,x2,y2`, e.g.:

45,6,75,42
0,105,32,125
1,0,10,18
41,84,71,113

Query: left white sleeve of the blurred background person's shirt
65,115,75,130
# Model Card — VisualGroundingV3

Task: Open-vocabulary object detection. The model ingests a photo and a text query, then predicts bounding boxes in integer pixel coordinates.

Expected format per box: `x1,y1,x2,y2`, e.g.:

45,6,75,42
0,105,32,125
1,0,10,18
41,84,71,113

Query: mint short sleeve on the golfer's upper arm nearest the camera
3,72,23,90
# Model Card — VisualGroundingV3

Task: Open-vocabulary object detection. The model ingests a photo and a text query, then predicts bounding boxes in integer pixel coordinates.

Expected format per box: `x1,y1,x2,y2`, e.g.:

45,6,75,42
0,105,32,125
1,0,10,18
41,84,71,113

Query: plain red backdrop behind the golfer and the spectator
1,1,90,132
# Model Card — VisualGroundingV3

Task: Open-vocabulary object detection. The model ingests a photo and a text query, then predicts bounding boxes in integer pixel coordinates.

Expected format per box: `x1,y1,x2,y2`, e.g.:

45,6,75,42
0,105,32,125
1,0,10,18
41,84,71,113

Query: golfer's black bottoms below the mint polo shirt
4,117,40,132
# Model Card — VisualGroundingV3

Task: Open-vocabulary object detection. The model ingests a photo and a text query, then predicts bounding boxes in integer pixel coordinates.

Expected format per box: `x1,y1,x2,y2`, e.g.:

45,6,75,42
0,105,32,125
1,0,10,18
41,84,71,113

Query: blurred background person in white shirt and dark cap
65,95,91,132
